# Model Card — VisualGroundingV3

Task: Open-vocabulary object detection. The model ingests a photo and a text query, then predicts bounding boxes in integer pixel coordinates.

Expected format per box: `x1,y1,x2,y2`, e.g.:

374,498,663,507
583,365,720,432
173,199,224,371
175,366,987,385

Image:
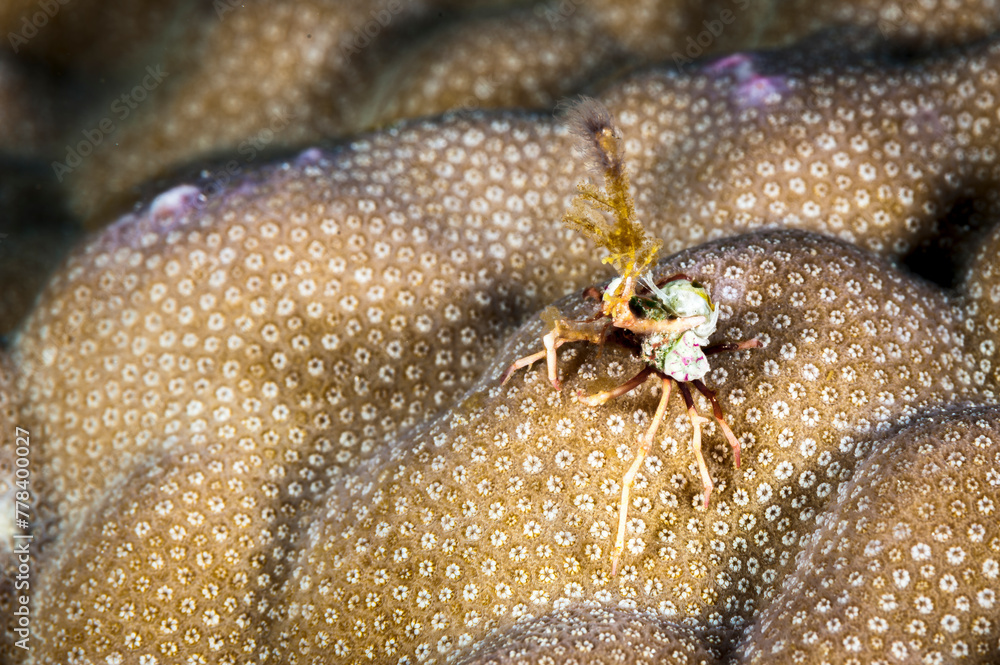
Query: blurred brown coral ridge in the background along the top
64,0,998,227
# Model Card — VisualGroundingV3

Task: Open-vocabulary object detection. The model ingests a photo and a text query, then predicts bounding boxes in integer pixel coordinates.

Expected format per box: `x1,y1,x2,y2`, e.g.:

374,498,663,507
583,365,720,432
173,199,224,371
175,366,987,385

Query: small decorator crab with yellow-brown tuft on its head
501,99,760,575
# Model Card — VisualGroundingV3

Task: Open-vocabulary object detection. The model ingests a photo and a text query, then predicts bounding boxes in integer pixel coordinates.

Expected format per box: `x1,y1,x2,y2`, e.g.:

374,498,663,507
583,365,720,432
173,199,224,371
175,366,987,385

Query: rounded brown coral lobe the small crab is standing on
272,233,995,662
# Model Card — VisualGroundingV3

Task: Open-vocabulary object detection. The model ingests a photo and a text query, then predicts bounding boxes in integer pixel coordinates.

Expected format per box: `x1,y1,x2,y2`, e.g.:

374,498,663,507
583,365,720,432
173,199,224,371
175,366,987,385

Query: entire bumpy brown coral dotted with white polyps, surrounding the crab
0,0,1000,665
